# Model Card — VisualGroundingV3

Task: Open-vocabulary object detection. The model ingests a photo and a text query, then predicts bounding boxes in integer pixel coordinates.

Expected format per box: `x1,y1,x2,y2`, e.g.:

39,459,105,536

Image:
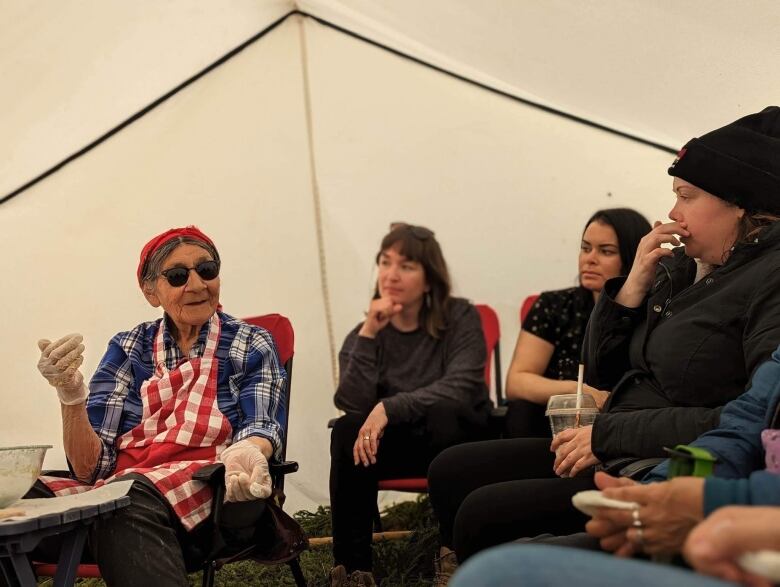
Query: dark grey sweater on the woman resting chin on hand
334,298,488,424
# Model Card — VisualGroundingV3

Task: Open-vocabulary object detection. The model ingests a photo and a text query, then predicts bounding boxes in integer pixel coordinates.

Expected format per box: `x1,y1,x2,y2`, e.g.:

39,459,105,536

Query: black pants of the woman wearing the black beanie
428,438,594,562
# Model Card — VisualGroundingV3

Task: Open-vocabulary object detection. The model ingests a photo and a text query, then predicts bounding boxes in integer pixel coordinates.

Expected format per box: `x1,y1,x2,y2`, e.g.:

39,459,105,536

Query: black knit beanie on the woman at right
669,106,780,214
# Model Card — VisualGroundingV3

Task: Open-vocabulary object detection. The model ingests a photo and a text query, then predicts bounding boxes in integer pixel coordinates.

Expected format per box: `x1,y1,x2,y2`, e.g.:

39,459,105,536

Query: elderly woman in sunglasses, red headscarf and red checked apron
28,226,286,586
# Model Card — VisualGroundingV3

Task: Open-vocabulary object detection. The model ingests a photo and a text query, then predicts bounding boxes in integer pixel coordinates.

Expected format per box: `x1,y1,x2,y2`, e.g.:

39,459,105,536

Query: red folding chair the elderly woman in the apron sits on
33,314,306,587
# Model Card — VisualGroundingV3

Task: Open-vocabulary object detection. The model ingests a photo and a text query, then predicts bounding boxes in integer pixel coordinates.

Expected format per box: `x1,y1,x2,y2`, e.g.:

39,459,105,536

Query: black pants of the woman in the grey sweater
330,403,487,572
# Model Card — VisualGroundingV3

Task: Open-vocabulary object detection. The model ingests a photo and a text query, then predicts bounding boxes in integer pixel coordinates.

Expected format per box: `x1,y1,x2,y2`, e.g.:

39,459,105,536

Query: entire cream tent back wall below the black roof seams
0,10,768,510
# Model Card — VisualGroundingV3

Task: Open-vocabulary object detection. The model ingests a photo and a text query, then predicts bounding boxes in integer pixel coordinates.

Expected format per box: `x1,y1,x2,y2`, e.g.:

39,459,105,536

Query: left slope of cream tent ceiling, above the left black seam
0,0,292,196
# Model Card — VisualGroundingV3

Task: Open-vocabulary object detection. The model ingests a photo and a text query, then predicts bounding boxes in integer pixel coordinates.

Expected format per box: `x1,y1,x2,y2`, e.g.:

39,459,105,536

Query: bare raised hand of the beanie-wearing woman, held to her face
615,220,691,308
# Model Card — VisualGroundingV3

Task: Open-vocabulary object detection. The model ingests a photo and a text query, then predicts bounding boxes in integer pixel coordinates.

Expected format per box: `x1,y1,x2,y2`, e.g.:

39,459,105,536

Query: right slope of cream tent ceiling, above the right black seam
299,0,780,147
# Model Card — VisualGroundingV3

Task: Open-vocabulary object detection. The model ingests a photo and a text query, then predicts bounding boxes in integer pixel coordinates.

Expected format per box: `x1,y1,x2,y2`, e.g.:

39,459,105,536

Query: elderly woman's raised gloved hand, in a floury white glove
38,334,89,406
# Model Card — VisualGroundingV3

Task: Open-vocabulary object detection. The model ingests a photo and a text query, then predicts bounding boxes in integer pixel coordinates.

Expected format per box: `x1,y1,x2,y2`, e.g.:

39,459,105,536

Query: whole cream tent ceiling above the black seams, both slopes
0,0,780,200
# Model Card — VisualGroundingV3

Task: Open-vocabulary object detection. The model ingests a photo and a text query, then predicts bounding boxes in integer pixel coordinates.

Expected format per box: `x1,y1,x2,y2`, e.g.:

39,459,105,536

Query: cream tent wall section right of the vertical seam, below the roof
306,21,674,400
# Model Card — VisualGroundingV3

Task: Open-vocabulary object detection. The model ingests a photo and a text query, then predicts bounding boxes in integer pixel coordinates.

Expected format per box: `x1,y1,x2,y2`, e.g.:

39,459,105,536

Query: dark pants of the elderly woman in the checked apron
3,475,265,587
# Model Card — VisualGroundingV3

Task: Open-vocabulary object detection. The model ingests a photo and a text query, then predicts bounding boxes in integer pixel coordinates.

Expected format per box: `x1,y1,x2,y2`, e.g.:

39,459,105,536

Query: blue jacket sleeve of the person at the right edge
642,347,780,482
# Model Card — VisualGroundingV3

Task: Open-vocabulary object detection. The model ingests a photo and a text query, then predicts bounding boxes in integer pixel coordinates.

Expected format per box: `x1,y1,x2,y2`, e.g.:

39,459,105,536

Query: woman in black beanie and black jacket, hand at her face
429,107,780,584
